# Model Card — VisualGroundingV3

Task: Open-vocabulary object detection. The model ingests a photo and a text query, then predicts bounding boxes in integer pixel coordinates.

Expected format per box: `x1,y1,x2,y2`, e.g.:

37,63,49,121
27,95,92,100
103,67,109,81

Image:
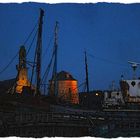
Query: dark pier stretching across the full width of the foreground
0,105,140,137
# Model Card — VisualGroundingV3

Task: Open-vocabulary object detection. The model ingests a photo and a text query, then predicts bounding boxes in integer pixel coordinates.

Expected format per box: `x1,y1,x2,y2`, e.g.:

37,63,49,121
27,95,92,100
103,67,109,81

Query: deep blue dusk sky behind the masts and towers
0,3,140,89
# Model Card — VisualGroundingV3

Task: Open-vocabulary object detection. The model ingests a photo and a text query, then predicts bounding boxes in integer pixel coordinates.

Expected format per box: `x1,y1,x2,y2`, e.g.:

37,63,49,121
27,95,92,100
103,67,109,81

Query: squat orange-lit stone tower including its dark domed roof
49,71,79,104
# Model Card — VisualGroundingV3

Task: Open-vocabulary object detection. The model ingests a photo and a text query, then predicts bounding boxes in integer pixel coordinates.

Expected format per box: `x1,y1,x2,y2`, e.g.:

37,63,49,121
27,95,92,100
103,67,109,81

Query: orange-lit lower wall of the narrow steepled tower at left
16,68,30,93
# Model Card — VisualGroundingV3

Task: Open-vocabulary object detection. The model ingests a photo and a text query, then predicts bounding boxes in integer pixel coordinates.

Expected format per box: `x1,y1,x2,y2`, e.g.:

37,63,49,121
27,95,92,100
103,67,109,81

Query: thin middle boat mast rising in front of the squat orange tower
53,21,58,96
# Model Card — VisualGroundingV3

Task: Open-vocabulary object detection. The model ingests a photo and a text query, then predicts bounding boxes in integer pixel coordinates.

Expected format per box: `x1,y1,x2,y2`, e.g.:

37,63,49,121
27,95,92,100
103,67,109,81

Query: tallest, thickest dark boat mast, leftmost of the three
36,9,44,95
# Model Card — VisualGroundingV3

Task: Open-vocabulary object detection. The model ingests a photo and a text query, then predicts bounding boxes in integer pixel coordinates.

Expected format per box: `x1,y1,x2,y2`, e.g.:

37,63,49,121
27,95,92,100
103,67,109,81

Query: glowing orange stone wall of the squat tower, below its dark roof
50,80,79,104
